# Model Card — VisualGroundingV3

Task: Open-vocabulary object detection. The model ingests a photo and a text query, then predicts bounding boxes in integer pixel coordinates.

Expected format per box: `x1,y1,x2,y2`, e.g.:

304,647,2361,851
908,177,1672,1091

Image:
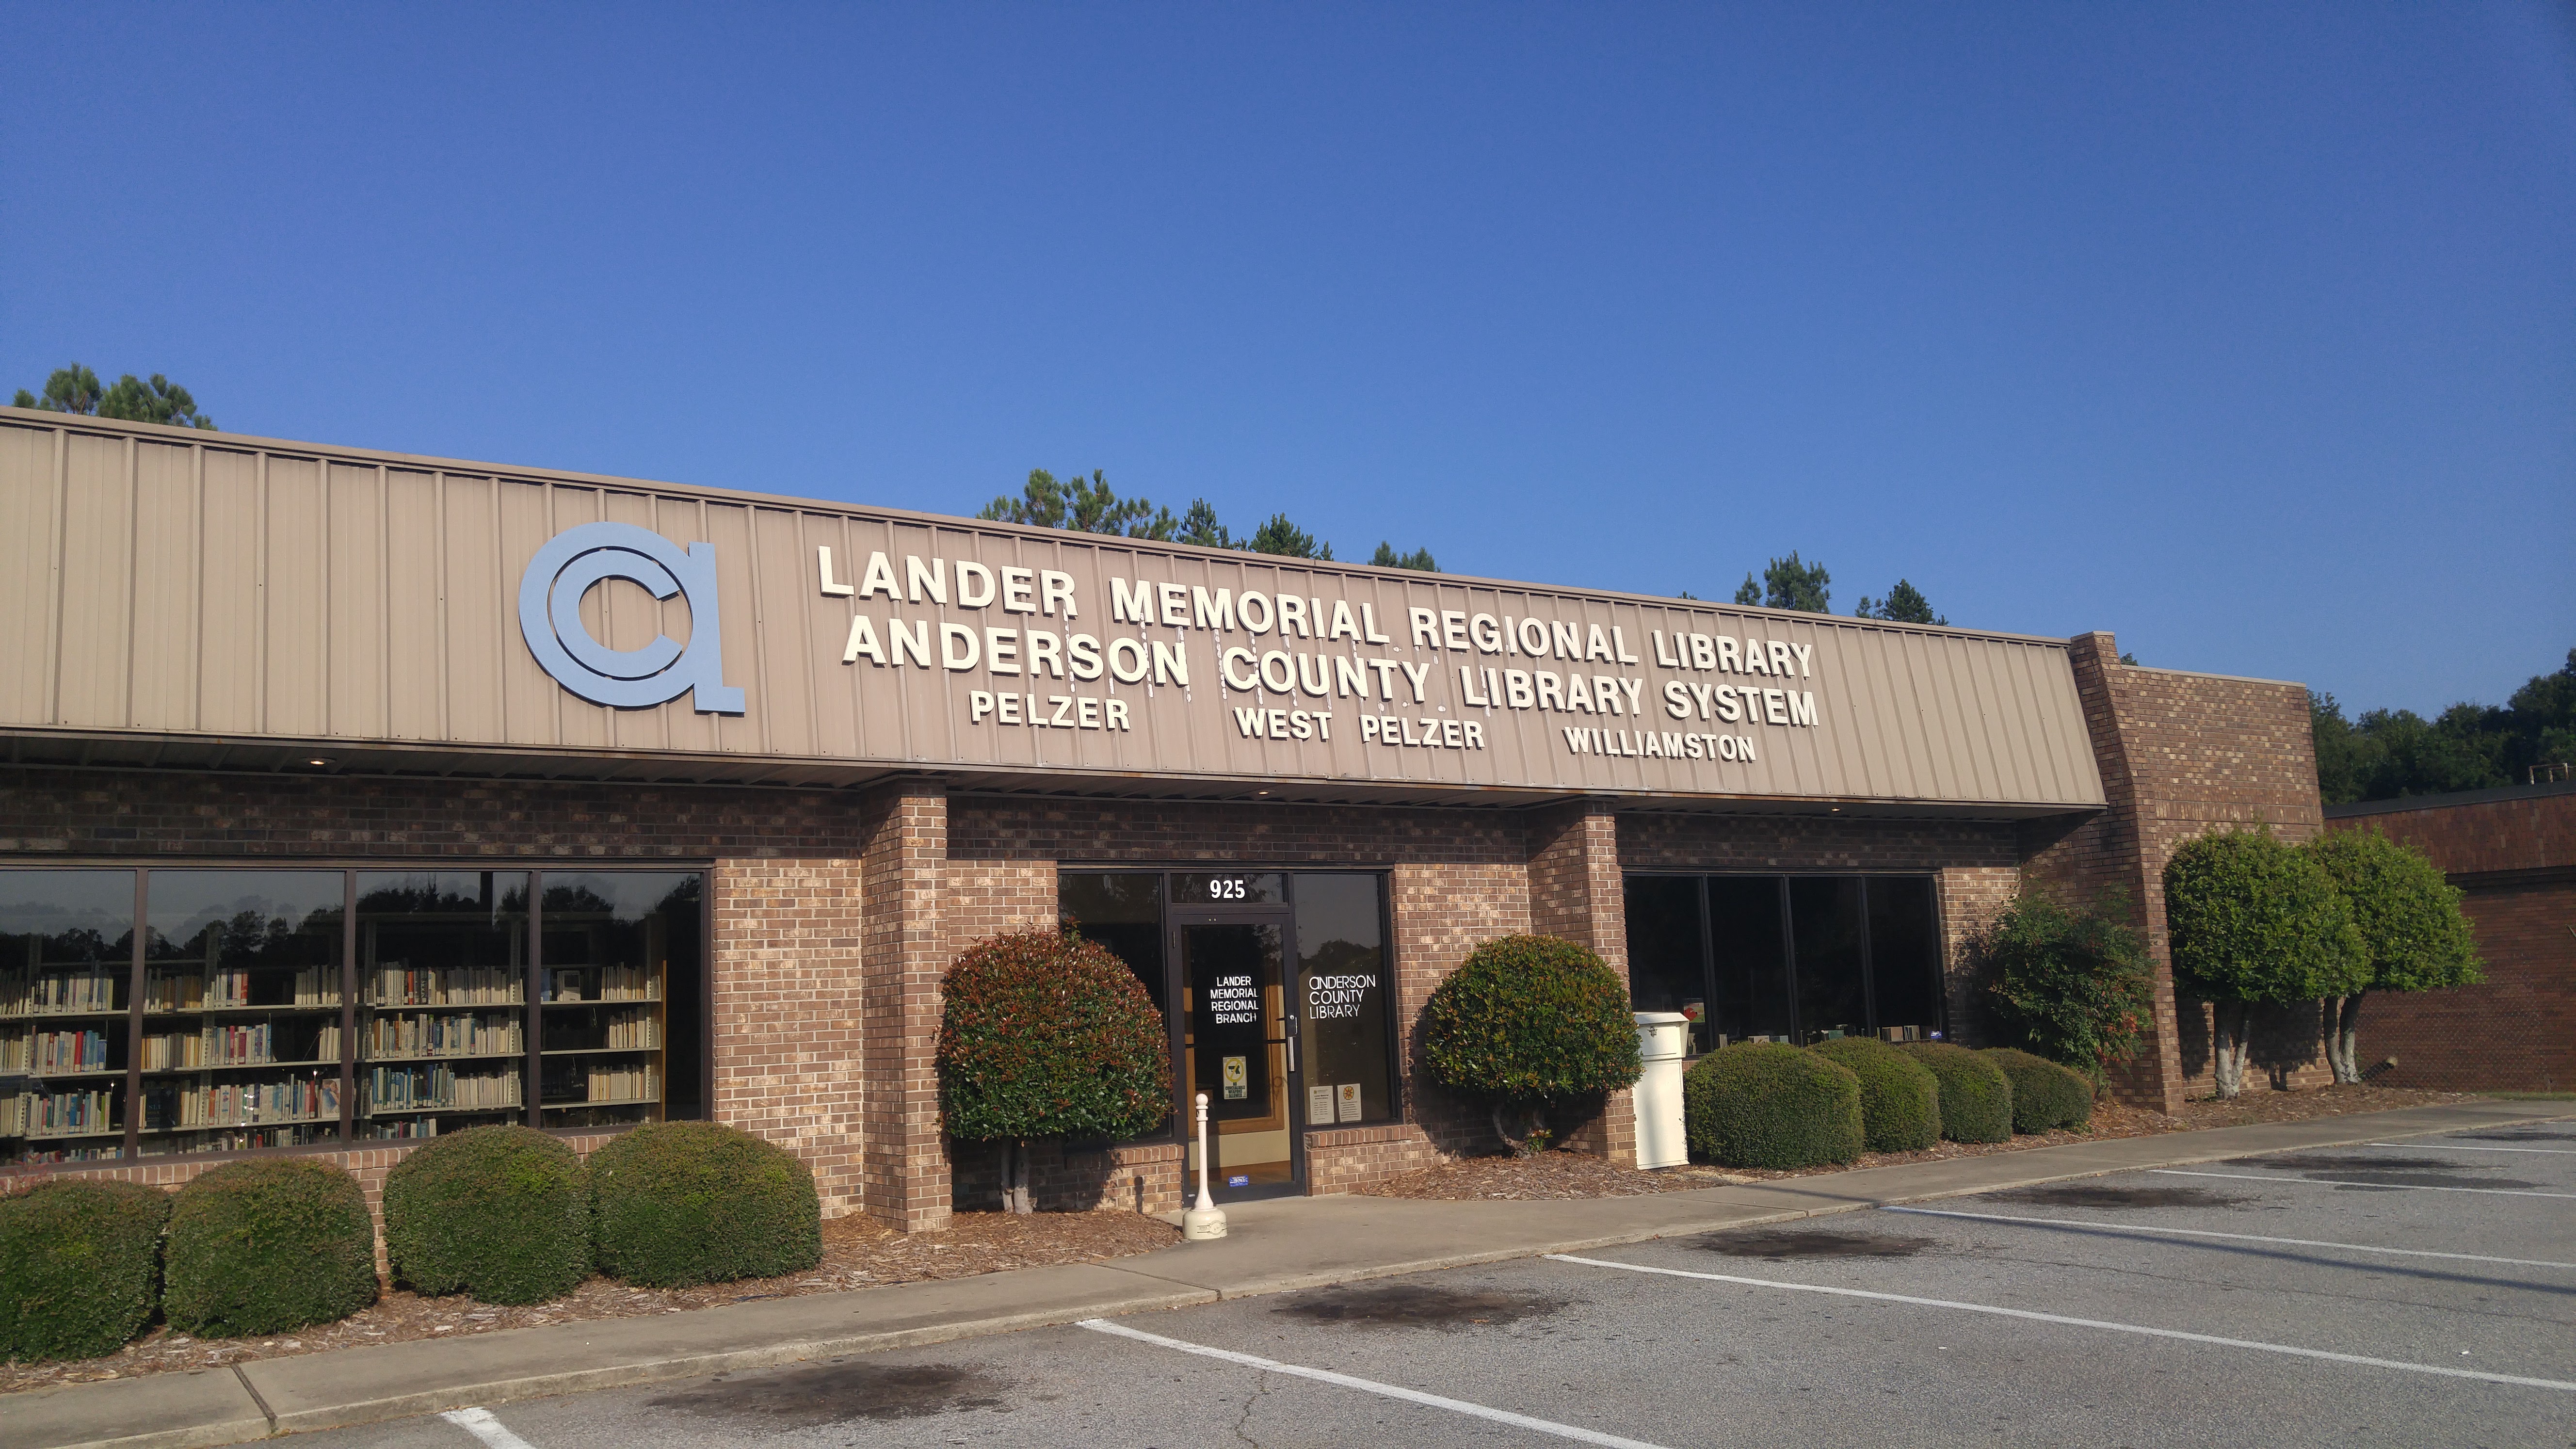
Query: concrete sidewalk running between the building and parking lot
0,1101,2568,1449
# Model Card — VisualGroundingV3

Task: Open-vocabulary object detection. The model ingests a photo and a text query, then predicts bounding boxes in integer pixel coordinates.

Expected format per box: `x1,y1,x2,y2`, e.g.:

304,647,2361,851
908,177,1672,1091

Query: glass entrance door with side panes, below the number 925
1056,871,1396,1189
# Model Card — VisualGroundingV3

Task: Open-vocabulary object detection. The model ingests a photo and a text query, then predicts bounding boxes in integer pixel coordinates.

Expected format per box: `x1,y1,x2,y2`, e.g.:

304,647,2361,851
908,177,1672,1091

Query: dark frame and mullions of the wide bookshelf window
0,856,716,1175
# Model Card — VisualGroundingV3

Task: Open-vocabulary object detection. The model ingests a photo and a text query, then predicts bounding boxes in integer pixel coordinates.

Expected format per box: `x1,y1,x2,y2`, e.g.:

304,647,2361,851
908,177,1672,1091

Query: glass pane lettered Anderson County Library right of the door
1296,871,1396,1127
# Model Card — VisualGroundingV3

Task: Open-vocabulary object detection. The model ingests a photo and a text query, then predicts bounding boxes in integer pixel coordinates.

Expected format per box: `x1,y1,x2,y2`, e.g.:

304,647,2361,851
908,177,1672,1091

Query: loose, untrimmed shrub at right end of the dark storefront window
1983,885,2154,1083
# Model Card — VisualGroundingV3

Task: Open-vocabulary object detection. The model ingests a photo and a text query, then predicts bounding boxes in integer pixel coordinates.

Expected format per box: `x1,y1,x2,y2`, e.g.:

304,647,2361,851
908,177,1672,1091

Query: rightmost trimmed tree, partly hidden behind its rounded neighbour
2305,830,2483,1083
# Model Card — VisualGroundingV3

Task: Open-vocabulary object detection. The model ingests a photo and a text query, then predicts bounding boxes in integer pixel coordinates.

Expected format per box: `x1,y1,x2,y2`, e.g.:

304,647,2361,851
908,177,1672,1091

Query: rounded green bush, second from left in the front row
162,1158,376,1338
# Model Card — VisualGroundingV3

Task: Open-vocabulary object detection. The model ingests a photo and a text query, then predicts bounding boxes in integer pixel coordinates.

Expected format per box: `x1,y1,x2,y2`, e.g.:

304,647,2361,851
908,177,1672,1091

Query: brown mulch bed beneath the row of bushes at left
0,1196,1180,1392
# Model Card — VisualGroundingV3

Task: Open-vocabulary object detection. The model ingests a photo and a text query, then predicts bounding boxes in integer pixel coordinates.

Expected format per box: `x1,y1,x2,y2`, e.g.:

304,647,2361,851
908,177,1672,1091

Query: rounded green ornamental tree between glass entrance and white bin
1422,936,1646,1153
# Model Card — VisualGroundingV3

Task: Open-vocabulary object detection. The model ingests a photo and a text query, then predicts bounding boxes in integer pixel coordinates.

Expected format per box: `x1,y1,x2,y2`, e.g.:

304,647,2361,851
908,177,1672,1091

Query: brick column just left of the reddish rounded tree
860,781,950,1232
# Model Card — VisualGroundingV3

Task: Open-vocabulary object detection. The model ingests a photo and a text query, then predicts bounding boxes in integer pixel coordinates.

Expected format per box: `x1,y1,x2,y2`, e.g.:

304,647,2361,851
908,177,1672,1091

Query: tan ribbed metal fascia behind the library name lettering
0,413,2102,807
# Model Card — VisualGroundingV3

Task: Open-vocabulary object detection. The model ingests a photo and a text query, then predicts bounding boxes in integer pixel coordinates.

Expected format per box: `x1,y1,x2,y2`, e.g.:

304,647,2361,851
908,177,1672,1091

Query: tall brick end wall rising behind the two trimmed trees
2022,634,2331,1111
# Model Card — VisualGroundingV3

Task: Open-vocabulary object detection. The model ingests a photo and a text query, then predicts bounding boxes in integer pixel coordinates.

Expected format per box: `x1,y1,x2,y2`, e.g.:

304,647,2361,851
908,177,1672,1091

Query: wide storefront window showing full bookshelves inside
0,869,706,1165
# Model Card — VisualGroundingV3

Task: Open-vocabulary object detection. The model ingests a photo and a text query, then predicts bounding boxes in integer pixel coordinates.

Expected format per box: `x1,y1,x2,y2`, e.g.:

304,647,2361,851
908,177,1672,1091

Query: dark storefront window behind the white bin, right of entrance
1628,874,1945,1052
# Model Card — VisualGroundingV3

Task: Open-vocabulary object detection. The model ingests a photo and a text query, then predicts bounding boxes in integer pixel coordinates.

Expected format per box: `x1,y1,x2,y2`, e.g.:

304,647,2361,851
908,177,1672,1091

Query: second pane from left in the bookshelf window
137,871,348,1155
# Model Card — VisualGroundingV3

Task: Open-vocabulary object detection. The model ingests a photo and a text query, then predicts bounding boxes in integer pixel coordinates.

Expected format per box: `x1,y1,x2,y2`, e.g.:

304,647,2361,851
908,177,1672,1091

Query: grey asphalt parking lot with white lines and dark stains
304,1122,2576,1449
